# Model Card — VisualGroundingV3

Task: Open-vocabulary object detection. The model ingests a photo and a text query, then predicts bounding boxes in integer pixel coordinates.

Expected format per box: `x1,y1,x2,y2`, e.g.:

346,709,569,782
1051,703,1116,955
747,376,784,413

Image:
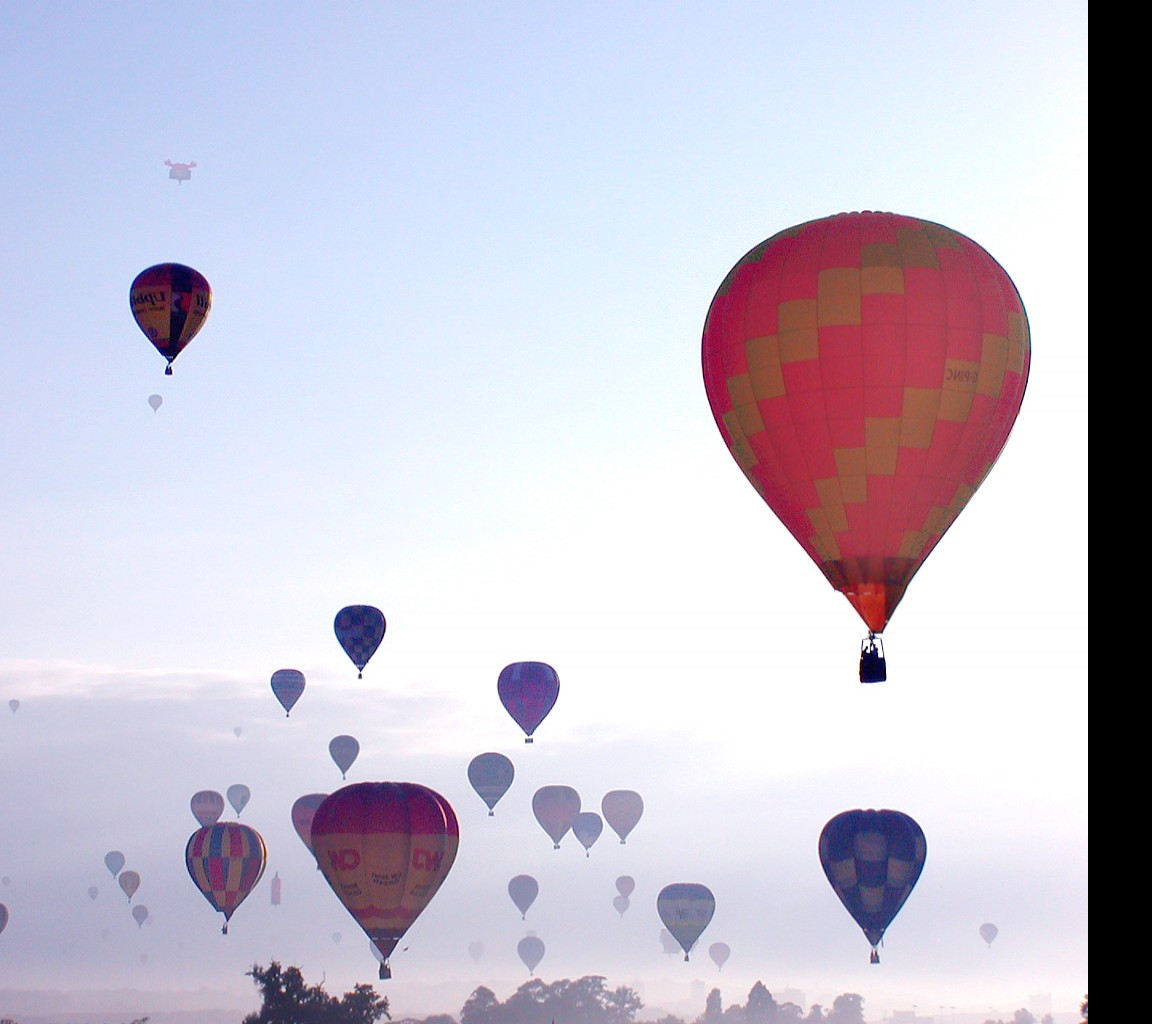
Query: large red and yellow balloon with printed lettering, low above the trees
312,782,460,979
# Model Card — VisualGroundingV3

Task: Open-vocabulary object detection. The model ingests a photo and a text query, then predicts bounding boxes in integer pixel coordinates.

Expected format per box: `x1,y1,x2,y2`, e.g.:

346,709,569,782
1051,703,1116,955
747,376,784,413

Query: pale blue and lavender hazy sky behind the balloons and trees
0,0,1087,1019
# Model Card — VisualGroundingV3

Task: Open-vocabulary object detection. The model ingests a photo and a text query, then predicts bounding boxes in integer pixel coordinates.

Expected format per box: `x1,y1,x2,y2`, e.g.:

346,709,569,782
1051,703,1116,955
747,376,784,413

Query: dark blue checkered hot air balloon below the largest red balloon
820,811,927,963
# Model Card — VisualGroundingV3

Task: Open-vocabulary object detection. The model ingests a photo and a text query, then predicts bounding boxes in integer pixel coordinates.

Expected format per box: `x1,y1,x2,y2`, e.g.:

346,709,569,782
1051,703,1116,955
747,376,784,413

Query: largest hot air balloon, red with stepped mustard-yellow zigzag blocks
703,212,1030,682
